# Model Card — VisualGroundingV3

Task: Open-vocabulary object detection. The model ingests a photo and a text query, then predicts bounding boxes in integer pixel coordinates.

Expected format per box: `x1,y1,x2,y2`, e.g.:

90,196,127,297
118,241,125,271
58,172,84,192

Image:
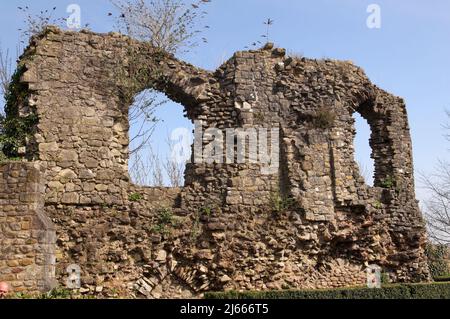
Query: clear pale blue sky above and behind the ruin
0,0,450,200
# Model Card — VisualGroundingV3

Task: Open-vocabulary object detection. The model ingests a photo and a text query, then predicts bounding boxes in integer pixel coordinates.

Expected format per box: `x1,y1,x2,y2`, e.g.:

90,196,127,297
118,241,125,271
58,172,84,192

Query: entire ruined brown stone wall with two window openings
0,27,429,298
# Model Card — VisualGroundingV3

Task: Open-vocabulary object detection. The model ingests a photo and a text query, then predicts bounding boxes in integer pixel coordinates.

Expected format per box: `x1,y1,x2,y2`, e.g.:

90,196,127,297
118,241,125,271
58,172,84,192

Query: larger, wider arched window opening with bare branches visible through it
128,89,193,187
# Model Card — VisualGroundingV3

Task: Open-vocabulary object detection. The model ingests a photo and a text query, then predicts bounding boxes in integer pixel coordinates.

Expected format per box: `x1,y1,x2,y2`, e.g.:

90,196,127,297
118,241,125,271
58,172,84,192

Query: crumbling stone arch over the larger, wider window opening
107,38,212,192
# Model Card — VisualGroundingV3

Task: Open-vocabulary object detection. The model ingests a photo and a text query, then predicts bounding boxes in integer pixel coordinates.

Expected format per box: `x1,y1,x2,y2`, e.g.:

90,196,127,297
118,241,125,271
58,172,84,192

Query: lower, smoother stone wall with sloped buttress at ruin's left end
0,163,56,292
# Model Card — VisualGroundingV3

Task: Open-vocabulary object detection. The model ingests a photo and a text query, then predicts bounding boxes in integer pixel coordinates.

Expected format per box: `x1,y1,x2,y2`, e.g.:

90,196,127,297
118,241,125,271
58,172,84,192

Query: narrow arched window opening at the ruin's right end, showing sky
353,112,375,186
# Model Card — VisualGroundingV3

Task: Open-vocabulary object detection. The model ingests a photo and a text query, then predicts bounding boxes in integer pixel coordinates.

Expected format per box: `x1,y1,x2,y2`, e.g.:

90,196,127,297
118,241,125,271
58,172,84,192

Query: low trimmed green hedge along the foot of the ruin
205,282,450,299
